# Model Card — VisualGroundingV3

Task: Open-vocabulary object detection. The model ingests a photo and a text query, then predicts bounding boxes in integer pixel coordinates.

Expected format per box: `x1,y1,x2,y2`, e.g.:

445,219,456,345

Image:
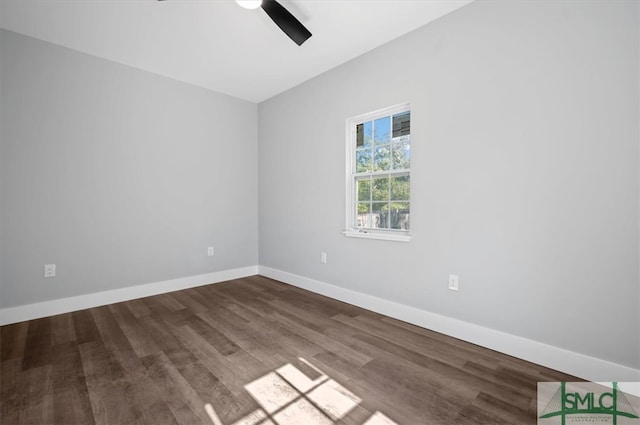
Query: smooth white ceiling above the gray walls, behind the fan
0,0,471,102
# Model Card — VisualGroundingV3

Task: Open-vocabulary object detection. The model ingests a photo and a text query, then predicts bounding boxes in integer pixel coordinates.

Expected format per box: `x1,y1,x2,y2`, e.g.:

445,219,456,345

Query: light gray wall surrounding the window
258,1,640,368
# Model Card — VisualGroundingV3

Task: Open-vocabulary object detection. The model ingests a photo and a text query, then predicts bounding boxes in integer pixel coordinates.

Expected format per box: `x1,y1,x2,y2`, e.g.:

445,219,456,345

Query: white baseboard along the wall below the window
258,266,640,382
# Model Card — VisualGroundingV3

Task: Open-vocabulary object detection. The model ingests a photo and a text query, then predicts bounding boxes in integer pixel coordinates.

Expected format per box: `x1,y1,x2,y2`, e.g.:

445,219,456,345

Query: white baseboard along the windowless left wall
0,266,258,325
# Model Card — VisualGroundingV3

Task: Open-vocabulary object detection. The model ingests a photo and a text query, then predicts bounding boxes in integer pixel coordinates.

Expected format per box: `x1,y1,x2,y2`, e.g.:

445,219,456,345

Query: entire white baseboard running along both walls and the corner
0,266,640,382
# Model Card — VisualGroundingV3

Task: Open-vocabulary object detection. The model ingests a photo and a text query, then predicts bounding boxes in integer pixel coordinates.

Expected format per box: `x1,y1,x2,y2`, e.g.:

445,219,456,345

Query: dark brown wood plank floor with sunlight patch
0,276,579,425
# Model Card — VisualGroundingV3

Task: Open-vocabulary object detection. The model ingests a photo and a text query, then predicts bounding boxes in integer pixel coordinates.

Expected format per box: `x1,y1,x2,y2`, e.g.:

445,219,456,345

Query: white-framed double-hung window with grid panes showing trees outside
344,104,411,241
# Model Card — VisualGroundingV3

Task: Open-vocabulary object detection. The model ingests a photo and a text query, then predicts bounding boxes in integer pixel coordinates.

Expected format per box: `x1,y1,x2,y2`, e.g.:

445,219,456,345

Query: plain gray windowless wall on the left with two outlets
0,30,258,308
